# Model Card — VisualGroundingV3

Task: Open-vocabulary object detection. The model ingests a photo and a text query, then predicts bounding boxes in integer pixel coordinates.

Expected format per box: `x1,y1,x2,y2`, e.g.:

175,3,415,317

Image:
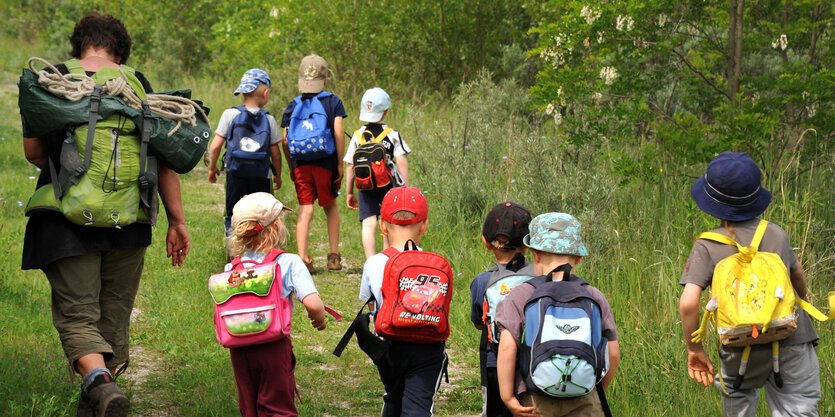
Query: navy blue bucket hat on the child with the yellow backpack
690,152,771,222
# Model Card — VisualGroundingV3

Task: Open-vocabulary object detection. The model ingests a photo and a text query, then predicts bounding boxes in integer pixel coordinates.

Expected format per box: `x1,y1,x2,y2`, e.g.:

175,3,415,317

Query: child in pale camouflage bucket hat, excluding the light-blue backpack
496,213,620,416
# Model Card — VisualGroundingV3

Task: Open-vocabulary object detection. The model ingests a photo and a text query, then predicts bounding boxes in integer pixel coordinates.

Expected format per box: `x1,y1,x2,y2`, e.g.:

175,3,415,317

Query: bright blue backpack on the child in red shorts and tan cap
287,91,336,161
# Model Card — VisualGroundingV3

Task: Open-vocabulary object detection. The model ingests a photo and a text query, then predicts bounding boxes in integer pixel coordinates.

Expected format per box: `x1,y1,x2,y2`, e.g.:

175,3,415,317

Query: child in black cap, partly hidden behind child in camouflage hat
470,201,535,417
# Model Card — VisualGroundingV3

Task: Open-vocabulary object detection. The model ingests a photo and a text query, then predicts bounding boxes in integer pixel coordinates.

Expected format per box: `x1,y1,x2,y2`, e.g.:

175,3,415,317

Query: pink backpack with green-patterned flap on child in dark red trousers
209,249,292,348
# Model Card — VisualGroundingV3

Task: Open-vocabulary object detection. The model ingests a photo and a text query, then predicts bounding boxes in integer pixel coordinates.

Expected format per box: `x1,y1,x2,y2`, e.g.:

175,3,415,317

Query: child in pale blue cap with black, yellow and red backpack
343,87,412,258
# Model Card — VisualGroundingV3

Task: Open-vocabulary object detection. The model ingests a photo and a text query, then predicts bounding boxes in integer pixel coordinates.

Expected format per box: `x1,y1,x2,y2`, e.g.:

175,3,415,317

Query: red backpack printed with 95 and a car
374,243,452,343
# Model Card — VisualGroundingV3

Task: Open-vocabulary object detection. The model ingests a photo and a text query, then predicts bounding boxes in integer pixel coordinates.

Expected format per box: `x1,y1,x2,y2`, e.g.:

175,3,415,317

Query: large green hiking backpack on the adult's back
26,59,158,228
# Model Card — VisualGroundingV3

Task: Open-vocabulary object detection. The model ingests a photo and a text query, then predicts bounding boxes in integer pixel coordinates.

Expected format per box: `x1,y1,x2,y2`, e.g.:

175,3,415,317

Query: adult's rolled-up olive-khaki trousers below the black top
43,248,145,369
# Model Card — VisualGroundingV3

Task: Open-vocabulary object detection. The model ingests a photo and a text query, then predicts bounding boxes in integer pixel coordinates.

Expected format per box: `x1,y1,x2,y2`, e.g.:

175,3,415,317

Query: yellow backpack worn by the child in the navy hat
692,220,835,389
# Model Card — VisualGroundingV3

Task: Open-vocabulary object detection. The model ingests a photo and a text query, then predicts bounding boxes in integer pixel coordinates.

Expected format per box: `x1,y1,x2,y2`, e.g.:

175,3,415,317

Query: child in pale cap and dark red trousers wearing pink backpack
209,193,327,417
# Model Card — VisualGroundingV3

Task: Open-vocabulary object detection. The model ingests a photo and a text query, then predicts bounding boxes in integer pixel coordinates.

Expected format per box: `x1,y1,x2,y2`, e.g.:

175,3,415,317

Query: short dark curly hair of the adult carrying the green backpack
70,12,132,64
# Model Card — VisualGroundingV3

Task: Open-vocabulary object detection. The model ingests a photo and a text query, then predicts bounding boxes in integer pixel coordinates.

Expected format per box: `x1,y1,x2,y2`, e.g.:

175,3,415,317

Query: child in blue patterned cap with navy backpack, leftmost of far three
209,68,281,239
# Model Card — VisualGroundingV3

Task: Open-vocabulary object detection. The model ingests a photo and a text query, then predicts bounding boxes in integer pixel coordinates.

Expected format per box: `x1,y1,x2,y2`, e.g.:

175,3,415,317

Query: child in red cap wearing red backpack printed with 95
344,187,452,417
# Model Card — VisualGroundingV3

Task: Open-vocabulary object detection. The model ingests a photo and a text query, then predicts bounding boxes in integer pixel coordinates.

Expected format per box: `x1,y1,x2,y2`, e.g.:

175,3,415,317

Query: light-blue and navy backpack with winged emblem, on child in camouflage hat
520,264,609,400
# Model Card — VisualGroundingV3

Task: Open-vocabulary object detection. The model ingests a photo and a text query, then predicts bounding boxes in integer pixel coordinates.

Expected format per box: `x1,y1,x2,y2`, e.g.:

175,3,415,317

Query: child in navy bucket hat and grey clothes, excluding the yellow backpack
679,152,821,417
